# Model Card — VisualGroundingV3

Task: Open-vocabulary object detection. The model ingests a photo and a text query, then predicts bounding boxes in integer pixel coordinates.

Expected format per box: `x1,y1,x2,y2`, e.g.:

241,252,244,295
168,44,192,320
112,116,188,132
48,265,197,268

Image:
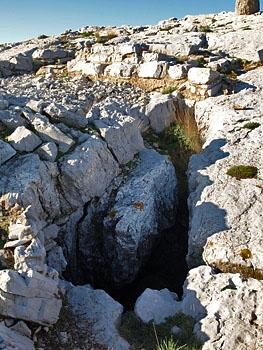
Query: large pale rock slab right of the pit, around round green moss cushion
187,68,263,278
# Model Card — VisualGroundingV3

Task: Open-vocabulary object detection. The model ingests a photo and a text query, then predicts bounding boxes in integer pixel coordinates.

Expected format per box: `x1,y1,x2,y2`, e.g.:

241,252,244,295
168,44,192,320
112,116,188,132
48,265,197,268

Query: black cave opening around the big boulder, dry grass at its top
60,98,202,311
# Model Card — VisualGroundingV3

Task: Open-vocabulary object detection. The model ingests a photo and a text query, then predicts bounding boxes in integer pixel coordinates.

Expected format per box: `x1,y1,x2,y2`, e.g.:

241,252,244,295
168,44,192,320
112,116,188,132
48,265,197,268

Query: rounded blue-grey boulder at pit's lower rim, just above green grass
134,288,181,324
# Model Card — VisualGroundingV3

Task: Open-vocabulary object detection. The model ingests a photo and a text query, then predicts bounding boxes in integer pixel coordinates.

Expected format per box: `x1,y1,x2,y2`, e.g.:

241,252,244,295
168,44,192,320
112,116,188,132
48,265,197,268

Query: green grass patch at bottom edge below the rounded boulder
119,311,201,350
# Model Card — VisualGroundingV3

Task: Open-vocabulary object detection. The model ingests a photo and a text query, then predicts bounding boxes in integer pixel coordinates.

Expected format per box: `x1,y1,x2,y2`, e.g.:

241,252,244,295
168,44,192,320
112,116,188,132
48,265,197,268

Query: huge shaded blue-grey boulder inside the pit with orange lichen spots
61,149,177,287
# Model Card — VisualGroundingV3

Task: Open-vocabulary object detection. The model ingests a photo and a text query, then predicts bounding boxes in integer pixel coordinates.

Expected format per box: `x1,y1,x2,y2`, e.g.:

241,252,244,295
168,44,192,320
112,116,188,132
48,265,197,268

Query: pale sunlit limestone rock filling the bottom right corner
182,266,263,350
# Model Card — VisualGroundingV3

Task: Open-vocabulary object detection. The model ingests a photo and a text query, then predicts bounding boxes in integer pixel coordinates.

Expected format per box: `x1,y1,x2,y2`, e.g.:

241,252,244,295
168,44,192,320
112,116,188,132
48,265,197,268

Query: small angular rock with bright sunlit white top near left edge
8,126,42,152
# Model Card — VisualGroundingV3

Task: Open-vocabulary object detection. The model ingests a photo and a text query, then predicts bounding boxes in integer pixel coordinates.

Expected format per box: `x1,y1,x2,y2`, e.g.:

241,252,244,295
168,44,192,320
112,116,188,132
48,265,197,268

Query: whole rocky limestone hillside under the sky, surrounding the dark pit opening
0,8,263,350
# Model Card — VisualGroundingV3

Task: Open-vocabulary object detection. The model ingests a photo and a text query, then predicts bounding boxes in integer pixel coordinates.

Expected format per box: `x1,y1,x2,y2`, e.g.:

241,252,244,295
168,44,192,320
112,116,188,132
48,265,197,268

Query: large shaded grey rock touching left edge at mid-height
0,154,60,219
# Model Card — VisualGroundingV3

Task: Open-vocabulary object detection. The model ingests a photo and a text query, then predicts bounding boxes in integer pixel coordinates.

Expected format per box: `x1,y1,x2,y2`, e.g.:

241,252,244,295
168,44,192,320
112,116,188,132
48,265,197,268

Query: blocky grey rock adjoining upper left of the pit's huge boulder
59,136,120,209
